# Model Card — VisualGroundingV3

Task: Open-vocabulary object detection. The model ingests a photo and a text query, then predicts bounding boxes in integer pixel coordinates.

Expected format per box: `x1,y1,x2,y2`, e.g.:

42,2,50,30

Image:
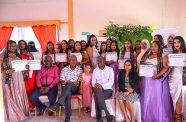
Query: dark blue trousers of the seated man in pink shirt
29,85,58,111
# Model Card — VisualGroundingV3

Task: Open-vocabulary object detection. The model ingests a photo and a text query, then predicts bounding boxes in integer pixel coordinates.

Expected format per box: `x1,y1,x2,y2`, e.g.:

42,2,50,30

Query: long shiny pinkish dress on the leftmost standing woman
2,57,30,122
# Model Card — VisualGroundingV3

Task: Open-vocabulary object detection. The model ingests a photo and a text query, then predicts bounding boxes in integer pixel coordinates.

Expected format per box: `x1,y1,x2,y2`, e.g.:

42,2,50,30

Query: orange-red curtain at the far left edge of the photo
0,27,13,51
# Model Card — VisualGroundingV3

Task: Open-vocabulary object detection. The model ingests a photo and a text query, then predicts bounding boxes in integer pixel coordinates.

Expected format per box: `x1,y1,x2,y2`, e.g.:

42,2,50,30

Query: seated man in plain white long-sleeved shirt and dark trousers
92,56,114,122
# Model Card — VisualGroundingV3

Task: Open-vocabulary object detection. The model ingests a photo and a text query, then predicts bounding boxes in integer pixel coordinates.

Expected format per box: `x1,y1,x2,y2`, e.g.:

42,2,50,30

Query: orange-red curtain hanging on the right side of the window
32,25,56,52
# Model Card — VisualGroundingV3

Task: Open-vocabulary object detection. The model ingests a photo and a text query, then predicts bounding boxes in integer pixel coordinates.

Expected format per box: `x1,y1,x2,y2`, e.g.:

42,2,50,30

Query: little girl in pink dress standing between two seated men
80,64,92,112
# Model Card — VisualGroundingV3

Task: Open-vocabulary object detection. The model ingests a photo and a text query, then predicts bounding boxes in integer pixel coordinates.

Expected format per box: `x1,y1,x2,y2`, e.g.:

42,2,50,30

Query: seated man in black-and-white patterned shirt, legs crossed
50,55,83,122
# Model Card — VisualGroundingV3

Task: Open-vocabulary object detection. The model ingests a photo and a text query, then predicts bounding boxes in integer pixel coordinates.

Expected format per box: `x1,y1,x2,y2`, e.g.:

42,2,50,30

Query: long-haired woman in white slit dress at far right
169,36,186,122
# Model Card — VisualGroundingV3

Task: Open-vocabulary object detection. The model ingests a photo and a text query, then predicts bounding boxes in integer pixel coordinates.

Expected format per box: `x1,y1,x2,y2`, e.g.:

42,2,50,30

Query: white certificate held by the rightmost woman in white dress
168,53,185,67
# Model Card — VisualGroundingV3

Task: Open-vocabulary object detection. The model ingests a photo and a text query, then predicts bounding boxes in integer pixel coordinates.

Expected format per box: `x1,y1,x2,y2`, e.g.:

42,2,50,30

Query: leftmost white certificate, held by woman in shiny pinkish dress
11,60,27,72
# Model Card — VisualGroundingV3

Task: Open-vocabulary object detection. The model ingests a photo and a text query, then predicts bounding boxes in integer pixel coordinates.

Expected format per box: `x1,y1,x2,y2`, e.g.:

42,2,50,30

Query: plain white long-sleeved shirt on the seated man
92,66,114,89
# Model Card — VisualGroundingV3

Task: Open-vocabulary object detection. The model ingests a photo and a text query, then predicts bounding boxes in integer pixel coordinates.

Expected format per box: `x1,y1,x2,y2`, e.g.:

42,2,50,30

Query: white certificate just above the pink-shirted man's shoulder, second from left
28,60,41,70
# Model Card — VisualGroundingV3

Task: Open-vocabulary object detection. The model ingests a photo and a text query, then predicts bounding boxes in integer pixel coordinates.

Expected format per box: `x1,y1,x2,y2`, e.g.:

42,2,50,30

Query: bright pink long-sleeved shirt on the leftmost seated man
36,65,59,88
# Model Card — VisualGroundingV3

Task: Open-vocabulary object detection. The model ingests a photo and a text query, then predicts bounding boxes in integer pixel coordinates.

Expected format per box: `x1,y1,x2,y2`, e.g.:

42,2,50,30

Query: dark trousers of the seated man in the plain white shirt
94,88,112,120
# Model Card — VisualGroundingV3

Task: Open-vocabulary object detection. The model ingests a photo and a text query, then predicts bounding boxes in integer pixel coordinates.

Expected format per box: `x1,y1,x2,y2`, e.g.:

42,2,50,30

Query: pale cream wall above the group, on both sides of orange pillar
0,0,186,40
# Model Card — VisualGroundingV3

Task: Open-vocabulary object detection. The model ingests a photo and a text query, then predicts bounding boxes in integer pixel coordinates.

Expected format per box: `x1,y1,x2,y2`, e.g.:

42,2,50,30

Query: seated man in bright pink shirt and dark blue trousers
30,56,59,116
